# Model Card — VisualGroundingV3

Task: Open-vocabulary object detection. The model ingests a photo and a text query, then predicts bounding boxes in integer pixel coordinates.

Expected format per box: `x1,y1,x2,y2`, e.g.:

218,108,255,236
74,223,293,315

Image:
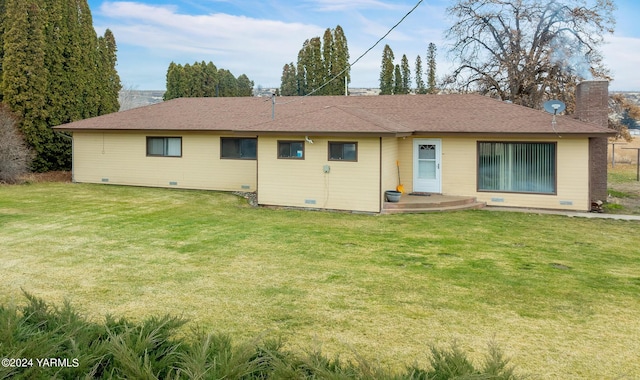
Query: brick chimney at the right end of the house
575,80,609,202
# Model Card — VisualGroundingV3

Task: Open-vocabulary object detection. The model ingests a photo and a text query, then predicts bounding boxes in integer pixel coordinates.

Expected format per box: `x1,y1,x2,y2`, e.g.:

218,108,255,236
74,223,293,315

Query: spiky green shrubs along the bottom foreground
0,293,517,380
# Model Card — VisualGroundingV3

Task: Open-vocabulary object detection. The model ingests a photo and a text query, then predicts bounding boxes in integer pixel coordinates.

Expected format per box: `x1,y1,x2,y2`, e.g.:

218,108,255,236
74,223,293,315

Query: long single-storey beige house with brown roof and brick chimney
55,81,612,213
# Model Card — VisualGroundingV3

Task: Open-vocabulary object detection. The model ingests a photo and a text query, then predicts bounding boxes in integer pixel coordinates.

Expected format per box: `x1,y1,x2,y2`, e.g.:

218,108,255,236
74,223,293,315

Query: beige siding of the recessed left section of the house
73,132,257,191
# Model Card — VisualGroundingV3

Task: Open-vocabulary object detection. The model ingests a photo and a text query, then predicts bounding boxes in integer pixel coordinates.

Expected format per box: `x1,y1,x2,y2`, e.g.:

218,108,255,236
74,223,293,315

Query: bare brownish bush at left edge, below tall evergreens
0,105,32,183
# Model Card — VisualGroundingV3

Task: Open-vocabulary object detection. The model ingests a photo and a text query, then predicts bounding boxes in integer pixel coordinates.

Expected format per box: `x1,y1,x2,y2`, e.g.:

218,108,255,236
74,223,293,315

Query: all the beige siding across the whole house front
73,132,590,212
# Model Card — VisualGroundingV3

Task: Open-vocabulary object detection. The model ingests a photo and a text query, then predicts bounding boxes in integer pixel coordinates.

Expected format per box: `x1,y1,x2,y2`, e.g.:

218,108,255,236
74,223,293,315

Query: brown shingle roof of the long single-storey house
56,94,611,135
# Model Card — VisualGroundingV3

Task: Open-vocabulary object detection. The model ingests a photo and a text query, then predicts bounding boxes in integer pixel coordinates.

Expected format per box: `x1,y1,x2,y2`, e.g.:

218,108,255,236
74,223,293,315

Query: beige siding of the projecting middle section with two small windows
258,136,381,212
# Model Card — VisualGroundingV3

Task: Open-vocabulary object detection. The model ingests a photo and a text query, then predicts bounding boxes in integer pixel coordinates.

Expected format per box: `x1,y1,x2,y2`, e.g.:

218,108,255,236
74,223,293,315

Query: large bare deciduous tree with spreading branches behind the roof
446,0,615,110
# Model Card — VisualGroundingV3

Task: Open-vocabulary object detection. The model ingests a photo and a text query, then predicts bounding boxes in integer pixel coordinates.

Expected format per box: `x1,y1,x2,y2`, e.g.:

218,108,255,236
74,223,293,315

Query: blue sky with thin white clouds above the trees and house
88,0,640,91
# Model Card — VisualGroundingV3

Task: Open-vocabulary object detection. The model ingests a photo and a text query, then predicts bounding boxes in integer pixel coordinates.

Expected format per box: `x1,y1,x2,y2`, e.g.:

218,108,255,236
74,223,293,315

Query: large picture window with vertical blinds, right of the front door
478,142,556,194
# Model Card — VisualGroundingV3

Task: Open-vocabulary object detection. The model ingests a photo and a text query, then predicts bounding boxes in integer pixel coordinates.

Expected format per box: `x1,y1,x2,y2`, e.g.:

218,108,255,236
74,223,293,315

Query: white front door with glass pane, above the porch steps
413,139,442,193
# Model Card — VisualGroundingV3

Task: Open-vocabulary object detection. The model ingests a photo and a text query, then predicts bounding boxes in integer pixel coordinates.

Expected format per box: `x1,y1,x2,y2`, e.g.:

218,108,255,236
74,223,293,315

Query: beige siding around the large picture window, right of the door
442,138,591,211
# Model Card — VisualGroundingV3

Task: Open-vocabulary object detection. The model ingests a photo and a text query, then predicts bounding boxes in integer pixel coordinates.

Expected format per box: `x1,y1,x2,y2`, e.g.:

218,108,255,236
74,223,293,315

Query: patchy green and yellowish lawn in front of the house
0,183,640,379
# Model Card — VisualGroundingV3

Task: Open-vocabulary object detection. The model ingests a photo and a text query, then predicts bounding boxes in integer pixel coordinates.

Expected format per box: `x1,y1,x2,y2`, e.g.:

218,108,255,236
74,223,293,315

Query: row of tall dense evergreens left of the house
0,0,121,171
